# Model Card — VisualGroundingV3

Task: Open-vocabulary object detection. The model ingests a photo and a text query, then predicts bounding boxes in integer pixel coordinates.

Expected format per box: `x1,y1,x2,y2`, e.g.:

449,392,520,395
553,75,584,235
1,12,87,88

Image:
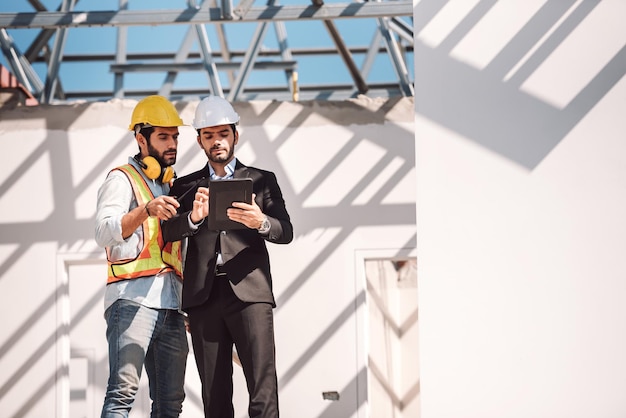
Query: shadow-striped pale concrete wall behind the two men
0,98,416,418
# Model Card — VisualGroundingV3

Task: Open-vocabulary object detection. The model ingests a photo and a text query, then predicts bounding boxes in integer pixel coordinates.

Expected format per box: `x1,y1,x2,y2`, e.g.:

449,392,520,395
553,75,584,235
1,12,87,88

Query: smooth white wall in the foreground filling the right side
415,0,626,418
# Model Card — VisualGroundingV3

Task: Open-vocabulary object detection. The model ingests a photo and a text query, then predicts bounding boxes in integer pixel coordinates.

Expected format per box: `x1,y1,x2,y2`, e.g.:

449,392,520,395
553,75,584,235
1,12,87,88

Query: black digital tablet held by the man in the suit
208,178,252,230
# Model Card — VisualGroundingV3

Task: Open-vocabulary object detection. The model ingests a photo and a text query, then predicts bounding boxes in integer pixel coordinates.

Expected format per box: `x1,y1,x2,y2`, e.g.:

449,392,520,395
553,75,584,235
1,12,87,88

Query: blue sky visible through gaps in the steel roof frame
0,0,412,96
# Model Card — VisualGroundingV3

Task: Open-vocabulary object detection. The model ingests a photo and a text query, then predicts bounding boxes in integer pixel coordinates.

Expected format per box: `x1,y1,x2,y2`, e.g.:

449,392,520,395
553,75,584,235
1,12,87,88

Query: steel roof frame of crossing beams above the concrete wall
0,0,414,103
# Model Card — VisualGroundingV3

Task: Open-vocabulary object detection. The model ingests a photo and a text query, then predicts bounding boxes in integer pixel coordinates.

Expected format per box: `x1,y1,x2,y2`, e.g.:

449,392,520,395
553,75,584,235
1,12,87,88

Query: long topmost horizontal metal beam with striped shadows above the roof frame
0,0,413,29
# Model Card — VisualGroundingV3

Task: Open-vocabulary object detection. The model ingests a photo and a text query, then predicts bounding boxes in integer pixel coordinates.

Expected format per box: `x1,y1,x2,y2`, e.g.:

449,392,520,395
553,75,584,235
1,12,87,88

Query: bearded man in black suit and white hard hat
158,96,293,418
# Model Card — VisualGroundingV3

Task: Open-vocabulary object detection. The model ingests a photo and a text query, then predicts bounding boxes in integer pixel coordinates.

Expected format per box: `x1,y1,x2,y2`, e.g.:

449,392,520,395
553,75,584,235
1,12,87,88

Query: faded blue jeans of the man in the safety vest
102,300,189,418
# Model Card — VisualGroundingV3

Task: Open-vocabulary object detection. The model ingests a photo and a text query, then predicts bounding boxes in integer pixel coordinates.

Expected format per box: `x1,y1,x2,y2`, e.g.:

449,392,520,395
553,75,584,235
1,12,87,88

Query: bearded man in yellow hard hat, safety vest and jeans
96,96,189,418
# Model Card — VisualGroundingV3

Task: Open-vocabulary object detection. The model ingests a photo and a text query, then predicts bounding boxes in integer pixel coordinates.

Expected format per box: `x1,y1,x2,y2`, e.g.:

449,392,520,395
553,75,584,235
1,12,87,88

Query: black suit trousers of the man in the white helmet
188,276,278,418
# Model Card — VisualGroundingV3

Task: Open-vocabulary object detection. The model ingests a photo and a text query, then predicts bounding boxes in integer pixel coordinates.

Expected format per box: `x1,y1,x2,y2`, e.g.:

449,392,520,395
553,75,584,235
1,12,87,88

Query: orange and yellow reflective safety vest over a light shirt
106,164,183,284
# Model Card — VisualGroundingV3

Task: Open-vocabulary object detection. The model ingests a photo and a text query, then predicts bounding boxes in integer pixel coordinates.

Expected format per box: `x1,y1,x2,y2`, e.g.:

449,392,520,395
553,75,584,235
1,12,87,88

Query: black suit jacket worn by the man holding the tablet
162,161,293,309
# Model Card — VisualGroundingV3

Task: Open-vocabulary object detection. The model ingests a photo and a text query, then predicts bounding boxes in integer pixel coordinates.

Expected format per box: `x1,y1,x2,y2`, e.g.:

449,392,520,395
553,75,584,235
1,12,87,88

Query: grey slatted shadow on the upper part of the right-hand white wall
415,0,626,170
